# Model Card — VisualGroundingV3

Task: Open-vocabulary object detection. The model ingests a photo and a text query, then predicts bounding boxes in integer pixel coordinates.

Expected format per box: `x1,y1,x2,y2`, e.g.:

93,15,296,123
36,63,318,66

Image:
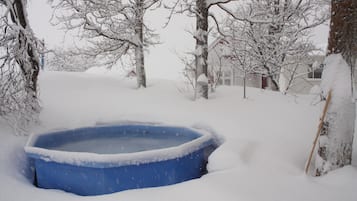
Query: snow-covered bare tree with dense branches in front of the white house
225,0,328,90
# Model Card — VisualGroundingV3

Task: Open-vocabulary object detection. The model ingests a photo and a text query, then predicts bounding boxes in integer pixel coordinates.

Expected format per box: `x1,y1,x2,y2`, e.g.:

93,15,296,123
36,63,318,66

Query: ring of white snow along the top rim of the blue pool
24,123,219,168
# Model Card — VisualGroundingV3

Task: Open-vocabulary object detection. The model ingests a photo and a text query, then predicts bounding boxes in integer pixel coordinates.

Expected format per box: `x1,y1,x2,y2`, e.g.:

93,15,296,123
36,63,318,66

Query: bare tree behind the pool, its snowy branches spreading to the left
53,0,160,87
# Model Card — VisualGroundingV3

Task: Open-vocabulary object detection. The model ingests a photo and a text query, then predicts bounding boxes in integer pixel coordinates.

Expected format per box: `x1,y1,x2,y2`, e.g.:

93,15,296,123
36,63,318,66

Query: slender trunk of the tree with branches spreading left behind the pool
135,0,146,88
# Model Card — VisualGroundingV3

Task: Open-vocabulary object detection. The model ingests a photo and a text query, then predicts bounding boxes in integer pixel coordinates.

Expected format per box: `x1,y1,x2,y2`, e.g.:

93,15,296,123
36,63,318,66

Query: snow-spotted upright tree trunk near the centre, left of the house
195,0,208,99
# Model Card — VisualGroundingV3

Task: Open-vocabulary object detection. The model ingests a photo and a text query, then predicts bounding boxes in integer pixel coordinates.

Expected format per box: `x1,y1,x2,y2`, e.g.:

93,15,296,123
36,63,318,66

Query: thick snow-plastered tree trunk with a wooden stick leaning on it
315,0,357,176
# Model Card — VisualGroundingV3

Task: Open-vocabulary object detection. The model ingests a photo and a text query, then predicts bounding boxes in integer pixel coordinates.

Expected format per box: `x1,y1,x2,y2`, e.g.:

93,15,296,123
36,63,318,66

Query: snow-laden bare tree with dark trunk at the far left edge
0,0,40,131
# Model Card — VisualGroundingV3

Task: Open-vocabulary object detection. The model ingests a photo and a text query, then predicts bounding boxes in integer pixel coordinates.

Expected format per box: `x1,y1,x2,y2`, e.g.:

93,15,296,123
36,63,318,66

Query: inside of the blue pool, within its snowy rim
34,126,200,154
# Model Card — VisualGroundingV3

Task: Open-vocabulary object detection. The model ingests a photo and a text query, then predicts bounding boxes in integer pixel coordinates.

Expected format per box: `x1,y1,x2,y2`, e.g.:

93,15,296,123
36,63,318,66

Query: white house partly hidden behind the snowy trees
208,38,324,93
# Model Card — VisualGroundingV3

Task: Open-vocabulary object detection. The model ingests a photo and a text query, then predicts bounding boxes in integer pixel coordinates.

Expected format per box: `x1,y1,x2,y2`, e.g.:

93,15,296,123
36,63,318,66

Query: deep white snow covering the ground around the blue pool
0,72,357,201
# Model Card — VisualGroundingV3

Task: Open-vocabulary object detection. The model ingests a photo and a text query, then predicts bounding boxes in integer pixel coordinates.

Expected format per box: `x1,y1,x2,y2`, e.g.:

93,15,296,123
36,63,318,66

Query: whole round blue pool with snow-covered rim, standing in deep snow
25,124,217,195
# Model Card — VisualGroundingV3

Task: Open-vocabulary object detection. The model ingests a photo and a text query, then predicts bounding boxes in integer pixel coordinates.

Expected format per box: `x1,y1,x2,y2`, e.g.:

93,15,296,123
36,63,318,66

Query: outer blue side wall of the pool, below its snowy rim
35,144,216,195
